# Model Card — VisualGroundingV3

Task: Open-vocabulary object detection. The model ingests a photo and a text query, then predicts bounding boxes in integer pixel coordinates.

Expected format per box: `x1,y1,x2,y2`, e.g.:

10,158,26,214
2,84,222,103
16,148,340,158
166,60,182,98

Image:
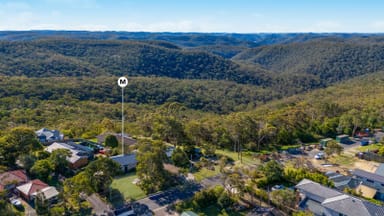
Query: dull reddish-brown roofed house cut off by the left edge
0,170,29,191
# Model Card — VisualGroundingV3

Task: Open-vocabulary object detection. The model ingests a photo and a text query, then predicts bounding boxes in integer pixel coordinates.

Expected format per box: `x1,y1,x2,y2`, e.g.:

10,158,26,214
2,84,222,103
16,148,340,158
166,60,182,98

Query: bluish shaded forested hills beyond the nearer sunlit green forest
0,31,384,106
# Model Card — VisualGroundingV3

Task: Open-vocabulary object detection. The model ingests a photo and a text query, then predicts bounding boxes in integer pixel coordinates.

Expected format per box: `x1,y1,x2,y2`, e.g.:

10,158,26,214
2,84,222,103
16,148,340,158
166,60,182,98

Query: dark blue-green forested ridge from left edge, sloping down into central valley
0,39,266,85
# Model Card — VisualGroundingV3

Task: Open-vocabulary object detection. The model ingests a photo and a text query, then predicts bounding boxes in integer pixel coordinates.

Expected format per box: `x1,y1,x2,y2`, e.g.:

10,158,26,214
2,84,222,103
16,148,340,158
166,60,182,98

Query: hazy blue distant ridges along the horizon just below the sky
0,30,384,47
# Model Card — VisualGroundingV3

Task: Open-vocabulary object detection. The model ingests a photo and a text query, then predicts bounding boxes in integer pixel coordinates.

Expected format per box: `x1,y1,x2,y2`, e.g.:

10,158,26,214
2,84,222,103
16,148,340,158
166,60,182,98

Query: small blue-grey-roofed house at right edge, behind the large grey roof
353,169,384,200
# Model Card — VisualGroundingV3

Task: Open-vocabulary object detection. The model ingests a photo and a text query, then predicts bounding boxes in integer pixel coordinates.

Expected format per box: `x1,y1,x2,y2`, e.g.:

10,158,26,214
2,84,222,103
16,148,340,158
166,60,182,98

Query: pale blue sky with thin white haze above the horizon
0,0,384,33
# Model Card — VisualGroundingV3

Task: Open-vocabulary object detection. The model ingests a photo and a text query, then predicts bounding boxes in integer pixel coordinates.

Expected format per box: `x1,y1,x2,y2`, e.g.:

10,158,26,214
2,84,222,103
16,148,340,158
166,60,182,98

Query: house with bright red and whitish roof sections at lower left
16,179,59,203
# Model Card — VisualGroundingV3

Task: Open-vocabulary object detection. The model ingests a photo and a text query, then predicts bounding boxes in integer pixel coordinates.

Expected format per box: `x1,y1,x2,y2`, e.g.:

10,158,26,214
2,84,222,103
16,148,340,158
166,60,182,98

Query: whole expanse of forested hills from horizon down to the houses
0,32,384,150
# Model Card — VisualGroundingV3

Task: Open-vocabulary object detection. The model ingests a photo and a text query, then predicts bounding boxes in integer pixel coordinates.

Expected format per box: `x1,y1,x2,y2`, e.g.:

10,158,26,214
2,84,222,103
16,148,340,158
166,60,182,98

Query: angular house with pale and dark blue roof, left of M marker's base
45,142,93,169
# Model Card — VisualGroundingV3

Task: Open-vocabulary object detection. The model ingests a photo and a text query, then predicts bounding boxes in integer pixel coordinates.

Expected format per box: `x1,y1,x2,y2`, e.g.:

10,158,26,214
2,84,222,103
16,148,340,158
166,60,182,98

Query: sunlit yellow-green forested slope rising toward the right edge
210,72,384,146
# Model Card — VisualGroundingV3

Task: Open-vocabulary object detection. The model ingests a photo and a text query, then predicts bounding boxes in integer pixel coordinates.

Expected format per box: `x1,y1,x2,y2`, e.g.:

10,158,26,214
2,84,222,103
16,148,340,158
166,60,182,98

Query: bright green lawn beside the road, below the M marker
111,172,146,200
